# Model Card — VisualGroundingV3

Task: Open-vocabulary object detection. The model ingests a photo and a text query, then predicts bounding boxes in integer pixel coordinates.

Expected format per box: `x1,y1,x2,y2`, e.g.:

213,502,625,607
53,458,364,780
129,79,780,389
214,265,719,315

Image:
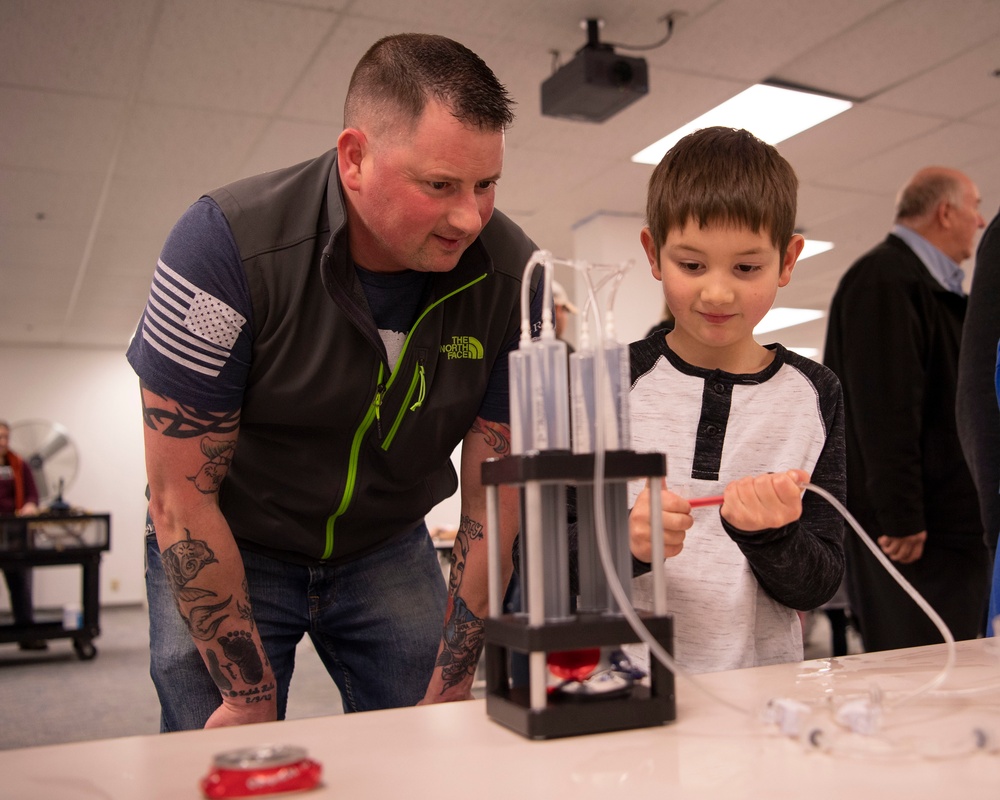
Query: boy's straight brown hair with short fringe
646,127,799,252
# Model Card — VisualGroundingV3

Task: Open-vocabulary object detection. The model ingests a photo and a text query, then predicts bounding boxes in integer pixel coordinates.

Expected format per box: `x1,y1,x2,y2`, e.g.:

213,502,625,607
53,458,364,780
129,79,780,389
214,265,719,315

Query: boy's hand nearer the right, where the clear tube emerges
722,469,809,531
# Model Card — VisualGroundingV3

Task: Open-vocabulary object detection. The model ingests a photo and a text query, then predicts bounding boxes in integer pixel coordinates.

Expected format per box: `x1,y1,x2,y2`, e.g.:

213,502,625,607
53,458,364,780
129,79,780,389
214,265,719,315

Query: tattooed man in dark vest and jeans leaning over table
129,34,540,730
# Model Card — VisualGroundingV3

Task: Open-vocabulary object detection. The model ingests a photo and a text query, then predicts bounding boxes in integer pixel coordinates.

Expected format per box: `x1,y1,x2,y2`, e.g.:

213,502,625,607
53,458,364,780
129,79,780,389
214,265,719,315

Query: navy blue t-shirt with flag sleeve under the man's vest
127,197,542,423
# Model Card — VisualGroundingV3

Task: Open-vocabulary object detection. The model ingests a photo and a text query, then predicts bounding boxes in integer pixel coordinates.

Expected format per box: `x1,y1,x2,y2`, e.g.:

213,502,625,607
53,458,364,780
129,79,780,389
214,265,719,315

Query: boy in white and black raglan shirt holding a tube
629,128,845,672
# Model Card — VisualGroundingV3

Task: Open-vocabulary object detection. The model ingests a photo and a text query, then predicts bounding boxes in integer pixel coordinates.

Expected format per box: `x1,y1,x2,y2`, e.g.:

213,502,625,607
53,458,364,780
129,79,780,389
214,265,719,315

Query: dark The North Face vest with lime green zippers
210,151,537,564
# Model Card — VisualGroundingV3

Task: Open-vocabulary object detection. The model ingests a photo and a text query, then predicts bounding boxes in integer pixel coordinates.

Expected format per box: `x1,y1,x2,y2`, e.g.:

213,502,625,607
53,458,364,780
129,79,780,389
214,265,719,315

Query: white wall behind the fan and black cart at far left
0,347,146,609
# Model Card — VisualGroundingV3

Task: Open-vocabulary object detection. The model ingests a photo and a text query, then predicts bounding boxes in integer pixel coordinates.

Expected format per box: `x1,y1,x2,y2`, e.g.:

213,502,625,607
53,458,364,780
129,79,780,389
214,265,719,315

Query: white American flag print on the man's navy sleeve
142,260,247,377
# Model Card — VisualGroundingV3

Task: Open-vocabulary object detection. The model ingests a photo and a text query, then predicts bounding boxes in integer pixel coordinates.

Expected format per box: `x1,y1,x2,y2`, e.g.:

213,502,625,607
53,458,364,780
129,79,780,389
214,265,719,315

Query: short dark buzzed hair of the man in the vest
344,33,514,132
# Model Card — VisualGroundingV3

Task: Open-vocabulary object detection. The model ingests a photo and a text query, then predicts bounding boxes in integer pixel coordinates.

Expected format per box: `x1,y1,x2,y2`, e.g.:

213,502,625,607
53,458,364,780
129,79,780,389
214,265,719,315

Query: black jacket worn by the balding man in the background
824,234,983,547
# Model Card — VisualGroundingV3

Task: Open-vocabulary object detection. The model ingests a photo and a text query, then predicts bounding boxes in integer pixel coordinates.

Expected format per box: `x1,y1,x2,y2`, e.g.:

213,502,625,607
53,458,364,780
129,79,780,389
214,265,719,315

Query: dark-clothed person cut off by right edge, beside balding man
955,206,1000,631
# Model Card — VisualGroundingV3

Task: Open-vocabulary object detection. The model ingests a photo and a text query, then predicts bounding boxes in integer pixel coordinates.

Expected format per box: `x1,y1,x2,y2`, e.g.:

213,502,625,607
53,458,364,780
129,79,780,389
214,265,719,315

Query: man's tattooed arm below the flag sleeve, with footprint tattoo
142,386,277,727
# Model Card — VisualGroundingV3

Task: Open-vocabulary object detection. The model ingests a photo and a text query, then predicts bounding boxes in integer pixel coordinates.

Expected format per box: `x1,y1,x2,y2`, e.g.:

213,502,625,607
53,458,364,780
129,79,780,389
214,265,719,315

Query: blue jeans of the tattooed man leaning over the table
146,523,447,732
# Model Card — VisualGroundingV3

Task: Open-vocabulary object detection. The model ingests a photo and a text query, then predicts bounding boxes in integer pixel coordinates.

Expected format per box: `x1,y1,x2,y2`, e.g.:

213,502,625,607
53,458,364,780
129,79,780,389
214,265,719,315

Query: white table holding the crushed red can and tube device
0,640,1000,800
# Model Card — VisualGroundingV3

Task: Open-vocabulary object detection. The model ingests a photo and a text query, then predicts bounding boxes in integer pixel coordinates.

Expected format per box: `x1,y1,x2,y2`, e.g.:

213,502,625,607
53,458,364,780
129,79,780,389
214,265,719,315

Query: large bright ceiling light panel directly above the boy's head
632,83,853,164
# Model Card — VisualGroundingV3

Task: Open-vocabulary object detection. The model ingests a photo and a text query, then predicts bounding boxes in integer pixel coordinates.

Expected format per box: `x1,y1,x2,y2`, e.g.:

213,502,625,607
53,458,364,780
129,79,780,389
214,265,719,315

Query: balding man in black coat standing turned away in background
825,167,988,650
